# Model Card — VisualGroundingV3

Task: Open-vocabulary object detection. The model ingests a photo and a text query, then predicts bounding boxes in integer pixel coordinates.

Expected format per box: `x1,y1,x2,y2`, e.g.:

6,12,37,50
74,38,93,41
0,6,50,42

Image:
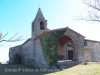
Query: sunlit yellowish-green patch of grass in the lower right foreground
46,64,100,75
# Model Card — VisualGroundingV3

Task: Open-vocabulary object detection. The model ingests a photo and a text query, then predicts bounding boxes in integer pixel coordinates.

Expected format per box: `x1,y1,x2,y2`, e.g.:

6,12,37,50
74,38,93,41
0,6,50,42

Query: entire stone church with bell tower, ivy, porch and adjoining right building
9,8,100,67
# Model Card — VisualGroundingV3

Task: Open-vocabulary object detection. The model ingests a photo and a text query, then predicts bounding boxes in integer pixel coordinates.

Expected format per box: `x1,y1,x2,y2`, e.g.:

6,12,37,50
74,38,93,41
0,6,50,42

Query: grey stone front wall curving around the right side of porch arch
64,29,84,62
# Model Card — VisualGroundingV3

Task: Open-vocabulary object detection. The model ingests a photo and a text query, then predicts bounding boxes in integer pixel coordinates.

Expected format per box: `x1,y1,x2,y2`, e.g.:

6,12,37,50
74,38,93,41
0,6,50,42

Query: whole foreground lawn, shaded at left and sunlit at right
0,64,100,75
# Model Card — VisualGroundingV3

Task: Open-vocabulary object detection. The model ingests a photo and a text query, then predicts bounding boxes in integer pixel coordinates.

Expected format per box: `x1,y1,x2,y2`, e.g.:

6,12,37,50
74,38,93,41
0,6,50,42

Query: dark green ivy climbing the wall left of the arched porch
40,30,66,66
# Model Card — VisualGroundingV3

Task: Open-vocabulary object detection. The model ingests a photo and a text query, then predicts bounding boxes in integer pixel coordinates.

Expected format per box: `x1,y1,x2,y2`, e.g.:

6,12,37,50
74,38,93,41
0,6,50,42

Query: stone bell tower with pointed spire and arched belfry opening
32,8,47,37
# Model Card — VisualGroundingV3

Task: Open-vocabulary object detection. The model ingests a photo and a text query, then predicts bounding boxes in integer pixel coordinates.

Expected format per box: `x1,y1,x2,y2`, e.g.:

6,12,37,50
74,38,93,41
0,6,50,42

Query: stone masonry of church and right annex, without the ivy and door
9,8,100,68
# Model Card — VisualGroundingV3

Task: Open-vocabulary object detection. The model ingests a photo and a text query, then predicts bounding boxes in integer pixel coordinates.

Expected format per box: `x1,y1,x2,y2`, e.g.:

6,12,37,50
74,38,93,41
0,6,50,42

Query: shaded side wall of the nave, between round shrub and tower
21,40,34,66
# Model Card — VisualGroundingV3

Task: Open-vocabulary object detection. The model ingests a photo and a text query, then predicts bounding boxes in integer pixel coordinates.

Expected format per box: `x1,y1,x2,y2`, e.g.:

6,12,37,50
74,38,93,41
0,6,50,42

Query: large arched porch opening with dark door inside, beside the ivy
58,35,76,61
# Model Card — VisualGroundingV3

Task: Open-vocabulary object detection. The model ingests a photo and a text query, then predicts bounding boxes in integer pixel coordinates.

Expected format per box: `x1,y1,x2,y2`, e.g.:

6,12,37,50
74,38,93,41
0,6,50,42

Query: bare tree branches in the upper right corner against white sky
79,0,100,22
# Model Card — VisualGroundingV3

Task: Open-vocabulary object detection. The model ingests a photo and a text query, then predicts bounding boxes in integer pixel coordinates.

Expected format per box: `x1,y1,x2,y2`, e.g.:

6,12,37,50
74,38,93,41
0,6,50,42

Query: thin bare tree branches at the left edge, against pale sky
0,32,23,42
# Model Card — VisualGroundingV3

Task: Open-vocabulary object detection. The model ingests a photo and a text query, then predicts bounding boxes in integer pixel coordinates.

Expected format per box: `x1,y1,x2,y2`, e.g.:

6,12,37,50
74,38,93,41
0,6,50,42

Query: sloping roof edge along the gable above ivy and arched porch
34,27,85,40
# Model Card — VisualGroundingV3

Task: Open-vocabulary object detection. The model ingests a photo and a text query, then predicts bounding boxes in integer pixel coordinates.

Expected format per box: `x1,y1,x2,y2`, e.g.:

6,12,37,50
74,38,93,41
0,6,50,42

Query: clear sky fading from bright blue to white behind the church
0,0,100,61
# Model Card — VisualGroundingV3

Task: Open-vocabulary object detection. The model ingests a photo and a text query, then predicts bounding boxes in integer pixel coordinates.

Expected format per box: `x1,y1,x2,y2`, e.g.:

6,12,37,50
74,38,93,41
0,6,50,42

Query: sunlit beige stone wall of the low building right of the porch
84,40,100,62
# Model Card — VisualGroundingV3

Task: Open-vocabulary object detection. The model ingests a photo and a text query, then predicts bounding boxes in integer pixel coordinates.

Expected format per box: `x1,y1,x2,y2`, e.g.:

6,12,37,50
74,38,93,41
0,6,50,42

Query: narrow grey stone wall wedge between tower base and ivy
34,39,48,68
